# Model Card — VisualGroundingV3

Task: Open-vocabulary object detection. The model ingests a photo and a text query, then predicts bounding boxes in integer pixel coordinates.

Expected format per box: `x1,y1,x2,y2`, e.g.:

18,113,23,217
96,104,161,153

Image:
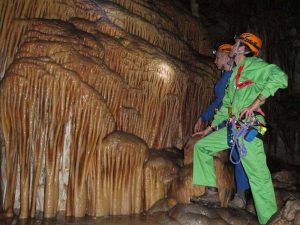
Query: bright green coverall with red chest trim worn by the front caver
193,57,288,224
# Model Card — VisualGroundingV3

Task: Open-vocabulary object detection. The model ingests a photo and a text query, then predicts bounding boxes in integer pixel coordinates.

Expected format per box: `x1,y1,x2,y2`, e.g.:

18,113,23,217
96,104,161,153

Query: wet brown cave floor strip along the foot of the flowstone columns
0,213,163,225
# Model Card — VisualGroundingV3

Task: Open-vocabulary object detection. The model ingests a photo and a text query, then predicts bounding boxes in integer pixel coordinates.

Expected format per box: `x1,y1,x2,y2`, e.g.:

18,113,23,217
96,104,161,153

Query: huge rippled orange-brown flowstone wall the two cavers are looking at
0,0,217,218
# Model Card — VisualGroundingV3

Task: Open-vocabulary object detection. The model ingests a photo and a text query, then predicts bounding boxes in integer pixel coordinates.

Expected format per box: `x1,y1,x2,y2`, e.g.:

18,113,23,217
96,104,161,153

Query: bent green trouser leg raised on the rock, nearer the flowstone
193,128,228,187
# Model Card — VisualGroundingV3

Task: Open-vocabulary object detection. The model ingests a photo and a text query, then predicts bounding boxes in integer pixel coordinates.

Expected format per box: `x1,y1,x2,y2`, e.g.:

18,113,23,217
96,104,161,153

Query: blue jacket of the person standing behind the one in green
200,71,232,121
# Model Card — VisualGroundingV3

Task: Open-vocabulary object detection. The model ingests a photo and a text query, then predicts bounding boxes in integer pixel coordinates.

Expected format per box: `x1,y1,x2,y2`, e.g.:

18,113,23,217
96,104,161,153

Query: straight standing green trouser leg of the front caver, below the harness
241,138,277,224
